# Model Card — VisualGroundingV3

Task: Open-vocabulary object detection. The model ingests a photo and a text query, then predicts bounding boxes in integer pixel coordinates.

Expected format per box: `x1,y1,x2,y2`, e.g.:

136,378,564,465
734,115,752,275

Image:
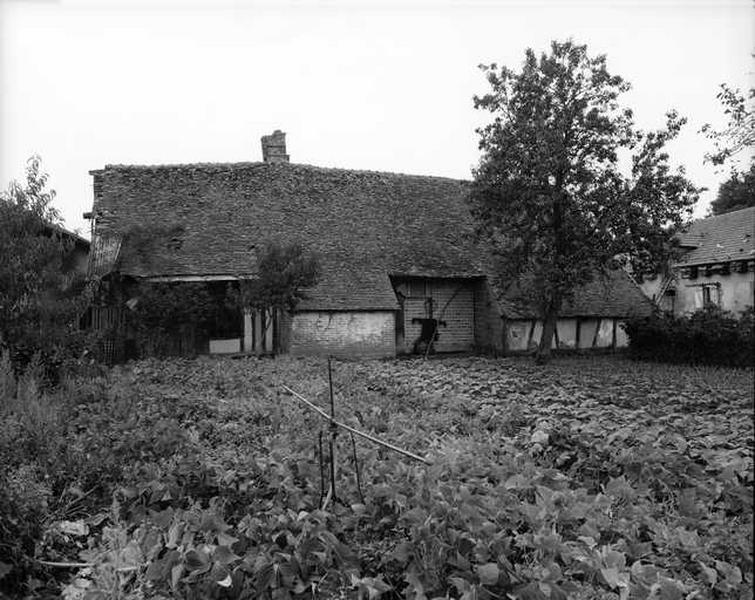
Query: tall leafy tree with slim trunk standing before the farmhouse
471,41,698,360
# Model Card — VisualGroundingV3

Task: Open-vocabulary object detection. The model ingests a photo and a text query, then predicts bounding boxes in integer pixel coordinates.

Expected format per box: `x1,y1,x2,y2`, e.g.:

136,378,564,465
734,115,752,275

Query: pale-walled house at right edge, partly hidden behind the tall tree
642,207,755,315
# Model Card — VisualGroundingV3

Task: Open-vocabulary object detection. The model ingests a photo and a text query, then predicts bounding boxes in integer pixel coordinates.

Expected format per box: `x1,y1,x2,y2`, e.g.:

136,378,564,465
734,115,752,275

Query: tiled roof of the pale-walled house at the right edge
678,207,755,265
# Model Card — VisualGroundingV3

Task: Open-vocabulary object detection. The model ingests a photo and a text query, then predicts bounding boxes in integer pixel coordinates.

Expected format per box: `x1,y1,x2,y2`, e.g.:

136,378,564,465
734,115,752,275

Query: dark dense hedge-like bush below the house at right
624,307,755,367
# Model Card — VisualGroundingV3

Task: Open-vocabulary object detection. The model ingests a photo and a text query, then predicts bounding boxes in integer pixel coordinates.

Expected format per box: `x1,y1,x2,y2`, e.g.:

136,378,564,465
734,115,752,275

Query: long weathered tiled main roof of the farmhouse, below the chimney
91,162,484,309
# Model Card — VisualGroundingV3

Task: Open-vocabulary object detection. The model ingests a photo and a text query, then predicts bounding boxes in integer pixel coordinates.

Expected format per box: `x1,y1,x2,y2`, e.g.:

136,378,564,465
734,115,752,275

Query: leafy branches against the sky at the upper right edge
700,83,755,165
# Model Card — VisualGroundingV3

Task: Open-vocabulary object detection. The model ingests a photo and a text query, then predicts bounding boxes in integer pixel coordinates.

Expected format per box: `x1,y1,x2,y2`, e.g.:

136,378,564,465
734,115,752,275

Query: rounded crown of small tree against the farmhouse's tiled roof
239,242,320,311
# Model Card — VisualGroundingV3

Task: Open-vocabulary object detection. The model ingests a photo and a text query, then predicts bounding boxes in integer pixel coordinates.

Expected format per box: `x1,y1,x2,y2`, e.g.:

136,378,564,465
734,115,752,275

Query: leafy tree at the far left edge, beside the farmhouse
0,156,84,378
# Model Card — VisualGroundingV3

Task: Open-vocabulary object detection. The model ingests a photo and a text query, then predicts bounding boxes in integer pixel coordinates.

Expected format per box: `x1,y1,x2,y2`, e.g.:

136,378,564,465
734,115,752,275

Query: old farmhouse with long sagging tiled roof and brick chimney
89,131,647,357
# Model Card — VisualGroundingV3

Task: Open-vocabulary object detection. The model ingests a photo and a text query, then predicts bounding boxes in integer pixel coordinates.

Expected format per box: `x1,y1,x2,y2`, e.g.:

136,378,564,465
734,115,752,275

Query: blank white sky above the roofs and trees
0,0,755,237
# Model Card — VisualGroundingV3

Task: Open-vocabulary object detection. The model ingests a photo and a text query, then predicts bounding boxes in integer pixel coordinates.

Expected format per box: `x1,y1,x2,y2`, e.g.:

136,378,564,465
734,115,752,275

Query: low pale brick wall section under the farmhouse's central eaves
288,311,396,358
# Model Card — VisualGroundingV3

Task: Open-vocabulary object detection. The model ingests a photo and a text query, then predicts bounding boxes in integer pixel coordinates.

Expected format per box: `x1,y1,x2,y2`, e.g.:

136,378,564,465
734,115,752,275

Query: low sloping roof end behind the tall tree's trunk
499,269,653,319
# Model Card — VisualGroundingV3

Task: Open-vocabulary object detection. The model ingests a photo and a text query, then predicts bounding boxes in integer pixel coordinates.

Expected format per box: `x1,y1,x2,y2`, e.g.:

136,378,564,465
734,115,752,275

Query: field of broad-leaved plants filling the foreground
0,357,753,600
